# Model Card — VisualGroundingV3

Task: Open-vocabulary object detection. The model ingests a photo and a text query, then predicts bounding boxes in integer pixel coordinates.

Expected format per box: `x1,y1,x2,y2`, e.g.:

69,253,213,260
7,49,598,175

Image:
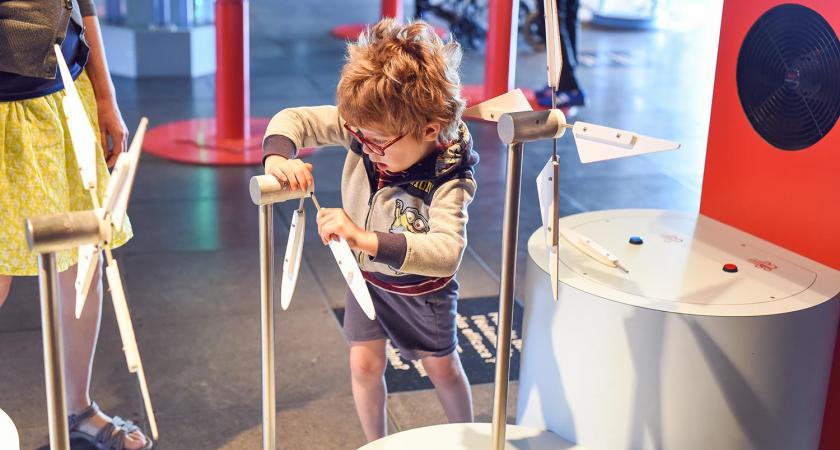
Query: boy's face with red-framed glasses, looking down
351,124,440,172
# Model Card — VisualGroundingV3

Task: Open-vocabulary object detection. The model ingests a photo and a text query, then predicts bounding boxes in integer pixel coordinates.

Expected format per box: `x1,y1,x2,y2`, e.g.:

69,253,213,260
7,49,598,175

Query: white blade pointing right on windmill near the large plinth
572,122,680,164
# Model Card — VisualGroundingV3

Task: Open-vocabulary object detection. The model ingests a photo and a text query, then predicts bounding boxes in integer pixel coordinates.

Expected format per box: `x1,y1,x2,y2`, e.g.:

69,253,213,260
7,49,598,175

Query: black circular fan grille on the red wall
737,4,840,150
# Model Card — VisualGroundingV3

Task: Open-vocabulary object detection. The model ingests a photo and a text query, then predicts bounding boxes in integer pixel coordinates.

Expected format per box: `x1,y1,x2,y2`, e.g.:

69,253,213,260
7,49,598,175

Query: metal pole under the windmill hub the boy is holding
259,204,277,450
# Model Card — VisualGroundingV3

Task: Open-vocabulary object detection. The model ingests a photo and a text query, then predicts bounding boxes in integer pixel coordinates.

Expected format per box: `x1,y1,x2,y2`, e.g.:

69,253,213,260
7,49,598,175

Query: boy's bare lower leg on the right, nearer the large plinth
422,351,473,423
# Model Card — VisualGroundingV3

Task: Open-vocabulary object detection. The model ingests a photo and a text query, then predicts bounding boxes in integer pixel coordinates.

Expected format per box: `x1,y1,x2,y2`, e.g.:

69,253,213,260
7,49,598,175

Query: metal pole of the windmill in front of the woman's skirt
38,253,70,450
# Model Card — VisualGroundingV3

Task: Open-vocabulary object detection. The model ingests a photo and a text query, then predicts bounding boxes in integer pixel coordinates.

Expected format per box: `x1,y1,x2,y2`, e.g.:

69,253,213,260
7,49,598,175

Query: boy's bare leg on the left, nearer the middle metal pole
350,339,388,442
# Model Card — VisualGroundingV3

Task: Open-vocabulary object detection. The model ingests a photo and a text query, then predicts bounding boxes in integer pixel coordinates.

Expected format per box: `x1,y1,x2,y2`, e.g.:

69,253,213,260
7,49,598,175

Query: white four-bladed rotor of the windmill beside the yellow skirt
55,45,158,440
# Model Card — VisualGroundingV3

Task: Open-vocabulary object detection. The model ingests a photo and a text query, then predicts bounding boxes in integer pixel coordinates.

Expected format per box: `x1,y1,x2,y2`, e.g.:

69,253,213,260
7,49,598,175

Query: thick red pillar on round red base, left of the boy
216,0,251,140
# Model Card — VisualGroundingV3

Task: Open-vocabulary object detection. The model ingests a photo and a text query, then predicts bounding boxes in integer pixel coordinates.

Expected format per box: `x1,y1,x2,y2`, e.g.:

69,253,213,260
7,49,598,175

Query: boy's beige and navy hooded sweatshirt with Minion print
263,106,478,295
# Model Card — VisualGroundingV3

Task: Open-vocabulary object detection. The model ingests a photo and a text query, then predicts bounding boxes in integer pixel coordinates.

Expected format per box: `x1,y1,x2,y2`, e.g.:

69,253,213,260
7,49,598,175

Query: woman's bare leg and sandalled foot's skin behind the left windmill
58,261,146,450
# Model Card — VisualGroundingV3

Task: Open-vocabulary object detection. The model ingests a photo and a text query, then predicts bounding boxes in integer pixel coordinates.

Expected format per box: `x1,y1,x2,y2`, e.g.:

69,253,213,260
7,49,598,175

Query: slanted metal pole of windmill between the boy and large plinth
493,143,524,450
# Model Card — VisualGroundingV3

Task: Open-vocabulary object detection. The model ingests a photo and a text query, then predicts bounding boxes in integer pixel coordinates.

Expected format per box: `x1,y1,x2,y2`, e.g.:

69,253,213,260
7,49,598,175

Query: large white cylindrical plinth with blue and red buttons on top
517,210,840,450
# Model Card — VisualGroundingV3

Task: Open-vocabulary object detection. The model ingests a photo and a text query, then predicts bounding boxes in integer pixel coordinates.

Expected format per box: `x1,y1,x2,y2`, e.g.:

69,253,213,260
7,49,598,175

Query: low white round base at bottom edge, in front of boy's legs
359,423,586,450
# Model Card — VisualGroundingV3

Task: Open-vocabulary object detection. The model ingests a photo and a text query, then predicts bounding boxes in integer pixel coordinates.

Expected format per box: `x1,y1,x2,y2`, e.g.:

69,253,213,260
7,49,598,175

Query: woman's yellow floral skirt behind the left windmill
0,72,132,276
